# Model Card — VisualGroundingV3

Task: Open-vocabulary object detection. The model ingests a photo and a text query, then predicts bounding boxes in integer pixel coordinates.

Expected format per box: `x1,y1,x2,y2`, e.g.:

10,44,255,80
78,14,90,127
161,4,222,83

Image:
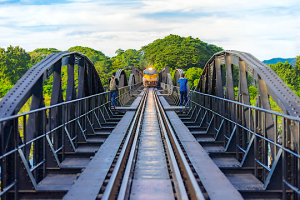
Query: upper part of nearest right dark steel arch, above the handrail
196,50,300,117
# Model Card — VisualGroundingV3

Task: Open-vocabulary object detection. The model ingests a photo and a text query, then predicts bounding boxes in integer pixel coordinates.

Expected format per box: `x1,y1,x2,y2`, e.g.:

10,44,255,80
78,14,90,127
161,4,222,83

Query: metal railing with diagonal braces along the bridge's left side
0,84,141,199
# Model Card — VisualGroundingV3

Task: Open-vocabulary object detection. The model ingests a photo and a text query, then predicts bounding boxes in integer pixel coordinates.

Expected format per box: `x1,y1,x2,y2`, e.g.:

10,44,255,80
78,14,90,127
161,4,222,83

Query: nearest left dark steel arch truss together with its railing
0,52,141,199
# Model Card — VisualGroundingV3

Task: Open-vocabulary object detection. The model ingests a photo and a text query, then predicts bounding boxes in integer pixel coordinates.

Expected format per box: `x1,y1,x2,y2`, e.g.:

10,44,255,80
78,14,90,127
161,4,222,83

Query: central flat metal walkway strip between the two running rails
130,90,174,199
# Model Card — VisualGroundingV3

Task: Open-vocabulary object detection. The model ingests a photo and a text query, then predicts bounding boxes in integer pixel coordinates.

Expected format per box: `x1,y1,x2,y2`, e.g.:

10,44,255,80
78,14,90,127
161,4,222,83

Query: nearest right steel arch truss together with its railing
190,51,300,199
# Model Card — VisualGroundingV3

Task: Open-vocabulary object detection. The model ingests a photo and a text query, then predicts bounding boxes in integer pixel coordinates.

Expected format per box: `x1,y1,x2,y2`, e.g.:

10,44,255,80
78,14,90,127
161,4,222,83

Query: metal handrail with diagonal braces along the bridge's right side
190,91,300,199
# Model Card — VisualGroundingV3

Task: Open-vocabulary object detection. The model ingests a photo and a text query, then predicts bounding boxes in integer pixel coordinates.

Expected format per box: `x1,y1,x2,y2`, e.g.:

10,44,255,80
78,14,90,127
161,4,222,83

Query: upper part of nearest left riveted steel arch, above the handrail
0,52,104,118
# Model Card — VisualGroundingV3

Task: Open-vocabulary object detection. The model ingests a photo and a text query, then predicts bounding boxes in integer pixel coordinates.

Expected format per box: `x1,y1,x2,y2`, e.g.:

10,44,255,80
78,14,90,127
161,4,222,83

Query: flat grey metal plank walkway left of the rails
63,112,134,200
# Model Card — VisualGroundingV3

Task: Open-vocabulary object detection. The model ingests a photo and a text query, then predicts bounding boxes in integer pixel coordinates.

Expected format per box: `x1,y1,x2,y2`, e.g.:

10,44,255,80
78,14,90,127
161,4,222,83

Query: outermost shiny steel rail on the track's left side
101,89,148,200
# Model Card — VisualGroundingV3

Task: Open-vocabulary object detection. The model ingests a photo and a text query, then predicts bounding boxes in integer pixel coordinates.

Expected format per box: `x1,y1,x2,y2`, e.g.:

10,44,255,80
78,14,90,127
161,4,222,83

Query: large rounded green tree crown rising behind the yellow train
141,35,223,70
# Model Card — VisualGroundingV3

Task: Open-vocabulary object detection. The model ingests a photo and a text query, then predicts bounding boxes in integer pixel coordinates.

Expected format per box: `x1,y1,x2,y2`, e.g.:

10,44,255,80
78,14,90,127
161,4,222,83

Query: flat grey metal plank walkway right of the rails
166,111,243,200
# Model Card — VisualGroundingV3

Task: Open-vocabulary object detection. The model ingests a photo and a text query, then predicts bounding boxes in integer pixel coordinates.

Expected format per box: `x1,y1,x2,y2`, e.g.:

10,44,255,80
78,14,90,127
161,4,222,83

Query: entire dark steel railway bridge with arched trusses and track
0,51,300,200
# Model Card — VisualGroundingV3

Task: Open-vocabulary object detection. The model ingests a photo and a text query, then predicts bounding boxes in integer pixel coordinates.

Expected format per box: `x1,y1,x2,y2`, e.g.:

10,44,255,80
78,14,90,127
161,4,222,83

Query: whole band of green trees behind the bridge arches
0,35,300,115
